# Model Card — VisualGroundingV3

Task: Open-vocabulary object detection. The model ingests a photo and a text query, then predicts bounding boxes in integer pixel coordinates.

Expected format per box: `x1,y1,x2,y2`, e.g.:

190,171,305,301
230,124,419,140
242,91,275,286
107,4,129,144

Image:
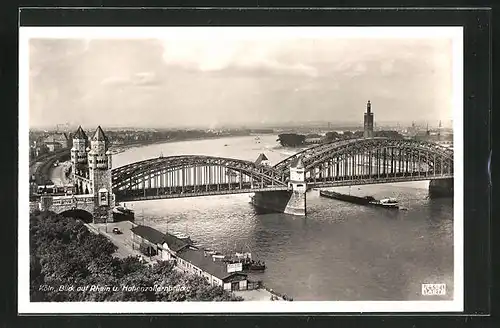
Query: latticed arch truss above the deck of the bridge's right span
274,138,453,178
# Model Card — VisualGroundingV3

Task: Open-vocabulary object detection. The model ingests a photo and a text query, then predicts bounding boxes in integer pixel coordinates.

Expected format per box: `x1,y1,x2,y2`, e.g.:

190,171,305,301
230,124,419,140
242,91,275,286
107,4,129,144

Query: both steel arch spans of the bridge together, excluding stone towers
112,138,453,201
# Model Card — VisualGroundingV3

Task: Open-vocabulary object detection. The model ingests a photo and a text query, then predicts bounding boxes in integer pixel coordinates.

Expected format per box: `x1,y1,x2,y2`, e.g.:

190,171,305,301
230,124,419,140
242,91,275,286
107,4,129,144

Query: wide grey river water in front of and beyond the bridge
113,135,453,301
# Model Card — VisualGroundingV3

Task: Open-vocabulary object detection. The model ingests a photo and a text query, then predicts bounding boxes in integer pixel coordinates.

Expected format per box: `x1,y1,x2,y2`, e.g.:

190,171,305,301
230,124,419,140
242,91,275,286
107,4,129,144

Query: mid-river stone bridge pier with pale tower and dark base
252,158,307,216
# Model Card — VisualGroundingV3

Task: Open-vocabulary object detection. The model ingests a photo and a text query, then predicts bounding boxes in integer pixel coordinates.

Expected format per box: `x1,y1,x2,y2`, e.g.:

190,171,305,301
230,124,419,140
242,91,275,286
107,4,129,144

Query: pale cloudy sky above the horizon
29,29,452,128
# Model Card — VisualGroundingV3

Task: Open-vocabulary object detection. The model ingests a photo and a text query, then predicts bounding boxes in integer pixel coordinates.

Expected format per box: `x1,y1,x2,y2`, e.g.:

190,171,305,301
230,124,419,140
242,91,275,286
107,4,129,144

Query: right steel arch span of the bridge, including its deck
274,137,453,187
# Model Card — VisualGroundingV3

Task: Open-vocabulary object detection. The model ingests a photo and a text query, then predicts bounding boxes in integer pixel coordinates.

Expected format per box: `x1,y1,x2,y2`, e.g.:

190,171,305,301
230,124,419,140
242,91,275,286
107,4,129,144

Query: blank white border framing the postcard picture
18,26,464,314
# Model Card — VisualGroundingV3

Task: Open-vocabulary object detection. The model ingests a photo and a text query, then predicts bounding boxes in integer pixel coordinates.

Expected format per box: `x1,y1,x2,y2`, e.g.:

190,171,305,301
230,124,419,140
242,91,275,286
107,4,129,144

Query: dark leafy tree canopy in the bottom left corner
30,212,242,302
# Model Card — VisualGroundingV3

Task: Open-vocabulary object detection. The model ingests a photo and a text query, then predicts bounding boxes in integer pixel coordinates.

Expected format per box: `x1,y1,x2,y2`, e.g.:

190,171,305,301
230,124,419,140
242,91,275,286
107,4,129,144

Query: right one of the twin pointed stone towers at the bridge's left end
88,126,115,222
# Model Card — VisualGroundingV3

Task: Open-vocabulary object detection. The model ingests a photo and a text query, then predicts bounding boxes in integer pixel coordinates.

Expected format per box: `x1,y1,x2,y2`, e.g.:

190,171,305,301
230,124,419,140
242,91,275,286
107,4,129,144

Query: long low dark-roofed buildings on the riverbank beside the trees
131,225,254,291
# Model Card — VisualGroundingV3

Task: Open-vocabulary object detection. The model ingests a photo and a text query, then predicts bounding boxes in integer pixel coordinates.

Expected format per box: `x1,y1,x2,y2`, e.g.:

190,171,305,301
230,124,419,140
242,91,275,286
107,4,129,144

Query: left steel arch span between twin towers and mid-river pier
112,155,287,201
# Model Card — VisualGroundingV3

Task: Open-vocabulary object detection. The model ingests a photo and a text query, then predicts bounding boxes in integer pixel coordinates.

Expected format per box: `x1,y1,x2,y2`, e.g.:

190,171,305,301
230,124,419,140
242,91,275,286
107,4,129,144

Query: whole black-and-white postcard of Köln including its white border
18,26,463,313
